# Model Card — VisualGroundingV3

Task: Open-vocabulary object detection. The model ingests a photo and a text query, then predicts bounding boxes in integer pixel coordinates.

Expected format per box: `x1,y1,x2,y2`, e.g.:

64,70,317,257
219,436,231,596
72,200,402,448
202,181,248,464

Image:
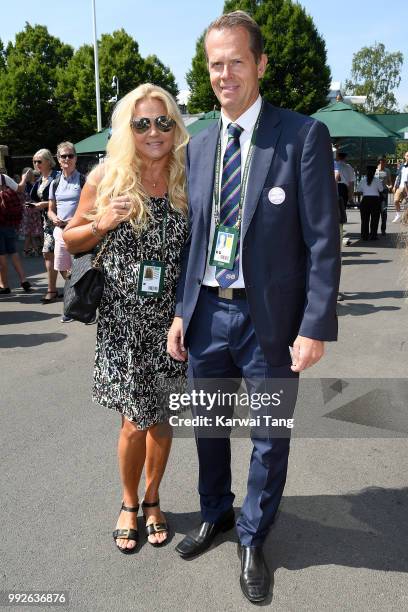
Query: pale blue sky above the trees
0,0,408,109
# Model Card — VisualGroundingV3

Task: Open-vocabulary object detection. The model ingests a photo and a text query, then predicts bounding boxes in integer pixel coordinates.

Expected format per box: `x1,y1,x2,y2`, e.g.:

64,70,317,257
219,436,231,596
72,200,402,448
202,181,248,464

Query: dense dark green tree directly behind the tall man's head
187,0,331,114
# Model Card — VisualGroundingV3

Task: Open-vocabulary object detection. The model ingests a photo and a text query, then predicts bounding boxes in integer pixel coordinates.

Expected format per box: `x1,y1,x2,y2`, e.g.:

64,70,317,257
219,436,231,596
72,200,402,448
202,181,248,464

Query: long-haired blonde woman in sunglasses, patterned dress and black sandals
64,84,188,554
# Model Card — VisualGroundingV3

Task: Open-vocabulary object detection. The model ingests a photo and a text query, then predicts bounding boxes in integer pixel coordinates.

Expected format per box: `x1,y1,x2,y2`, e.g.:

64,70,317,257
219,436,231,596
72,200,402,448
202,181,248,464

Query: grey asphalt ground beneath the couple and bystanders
0,211,408,612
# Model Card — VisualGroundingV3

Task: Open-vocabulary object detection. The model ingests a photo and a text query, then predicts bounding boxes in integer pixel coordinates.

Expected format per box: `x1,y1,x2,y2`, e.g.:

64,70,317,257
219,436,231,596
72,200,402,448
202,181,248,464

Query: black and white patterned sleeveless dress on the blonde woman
92,197,188,429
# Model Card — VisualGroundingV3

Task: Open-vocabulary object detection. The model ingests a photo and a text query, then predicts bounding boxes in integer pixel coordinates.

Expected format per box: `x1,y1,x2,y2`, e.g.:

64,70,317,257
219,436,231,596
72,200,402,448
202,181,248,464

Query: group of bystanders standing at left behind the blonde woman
0,142,85,323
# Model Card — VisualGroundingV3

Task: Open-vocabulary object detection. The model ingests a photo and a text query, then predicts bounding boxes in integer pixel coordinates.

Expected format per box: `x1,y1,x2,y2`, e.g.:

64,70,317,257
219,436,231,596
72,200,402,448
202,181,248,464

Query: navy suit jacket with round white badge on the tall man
176,102,340,365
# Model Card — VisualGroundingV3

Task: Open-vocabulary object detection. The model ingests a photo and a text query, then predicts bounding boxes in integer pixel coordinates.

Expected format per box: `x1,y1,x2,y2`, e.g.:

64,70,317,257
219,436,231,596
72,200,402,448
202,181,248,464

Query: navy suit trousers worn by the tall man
188,287,299,546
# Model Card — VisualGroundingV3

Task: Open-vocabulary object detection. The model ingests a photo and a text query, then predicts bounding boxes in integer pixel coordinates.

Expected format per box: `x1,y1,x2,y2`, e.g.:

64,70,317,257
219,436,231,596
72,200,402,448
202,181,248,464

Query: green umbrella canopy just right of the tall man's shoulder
312,102,397,138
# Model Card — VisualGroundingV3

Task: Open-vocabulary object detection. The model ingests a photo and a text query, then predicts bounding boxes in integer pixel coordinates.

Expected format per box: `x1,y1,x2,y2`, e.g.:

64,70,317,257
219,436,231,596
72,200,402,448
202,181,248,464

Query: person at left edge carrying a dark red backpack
0,173,31,295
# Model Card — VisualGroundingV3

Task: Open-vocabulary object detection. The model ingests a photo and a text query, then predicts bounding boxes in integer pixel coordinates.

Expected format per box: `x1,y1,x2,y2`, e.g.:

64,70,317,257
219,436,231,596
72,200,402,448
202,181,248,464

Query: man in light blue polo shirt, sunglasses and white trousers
48,142,86,323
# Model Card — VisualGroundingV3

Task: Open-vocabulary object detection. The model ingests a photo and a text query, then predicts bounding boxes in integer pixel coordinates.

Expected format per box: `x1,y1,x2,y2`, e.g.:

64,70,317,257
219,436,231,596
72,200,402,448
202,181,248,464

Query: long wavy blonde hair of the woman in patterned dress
89,83,189,227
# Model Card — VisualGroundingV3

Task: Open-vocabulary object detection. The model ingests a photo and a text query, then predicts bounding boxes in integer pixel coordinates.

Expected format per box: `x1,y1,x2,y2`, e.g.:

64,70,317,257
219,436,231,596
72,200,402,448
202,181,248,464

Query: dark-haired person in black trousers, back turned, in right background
357,166,383,240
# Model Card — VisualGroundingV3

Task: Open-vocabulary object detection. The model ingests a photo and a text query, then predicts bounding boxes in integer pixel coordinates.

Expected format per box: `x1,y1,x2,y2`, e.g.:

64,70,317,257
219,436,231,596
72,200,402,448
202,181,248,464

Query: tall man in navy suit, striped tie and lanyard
168,11,340,602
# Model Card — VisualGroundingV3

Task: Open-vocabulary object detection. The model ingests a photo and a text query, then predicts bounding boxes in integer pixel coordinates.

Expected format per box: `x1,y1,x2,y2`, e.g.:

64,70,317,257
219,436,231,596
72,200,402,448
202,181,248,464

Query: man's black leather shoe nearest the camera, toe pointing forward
238,544,271,603
